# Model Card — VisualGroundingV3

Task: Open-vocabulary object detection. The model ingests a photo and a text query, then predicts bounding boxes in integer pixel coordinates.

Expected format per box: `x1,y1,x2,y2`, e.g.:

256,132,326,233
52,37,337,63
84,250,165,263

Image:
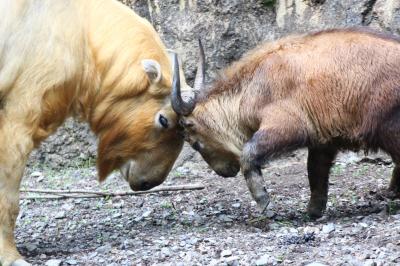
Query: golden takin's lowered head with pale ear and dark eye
93,53,189,191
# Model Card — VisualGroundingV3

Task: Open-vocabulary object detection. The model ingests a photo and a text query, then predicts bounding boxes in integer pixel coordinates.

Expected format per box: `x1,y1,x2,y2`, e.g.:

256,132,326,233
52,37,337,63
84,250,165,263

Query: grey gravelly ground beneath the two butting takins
16,151,400,265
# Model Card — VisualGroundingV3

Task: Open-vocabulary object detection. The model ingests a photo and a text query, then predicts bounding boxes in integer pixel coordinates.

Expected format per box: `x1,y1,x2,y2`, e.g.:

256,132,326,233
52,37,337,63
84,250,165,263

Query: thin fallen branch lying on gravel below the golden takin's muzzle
20,184,205,199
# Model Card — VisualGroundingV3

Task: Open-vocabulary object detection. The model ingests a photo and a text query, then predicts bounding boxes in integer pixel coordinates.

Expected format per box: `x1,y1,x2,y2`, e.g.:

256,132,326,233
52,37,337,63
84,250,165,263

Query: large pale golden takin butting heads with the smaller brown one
0,0,183,266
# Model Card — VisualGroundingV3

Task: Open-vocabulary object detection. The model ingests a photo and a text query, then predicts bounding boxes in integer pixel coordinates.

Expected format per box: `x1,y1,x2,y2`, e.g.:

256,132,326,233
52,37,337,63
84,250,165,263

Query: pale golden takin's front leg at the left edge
0,125,33,266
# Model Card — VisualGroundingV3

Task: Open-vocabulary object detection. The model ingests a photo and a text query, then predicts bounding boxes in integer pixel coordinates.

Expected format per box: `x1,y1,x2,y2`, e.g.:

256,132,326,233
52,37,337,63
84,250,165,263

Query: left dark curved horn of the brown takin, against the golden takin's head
171,54,196,115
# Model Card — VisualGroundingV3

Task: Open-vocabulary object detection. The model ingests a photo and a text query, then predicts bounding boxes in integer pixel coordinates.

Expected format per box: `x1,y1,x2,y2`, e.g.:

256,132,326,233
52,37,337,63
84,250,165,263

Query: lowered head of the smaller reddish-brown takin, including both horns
171,41,240,177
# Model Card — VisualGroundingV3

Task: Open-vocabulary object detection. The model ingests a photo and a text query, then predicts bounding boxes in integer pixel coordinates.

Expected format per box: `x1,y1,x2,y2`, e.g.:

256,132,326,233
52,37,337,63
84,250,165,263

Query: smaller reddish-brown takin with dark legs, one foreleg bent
172,28,400,220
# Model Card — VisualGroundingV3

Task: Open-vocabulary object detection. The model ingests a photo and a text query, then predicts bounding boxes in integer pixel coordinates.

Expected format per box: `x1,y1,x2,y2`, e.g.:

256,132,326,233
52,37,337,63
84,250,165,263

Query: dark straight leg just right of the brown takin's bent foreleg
307,147,337,218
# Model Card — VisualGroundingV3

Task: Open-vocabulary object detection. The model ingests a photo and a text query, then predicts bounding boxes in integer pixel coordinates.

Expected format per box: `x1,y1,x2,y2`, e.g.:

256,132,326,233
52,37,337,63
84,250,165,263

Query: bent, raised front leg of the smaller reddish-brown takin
241,107,307,212
